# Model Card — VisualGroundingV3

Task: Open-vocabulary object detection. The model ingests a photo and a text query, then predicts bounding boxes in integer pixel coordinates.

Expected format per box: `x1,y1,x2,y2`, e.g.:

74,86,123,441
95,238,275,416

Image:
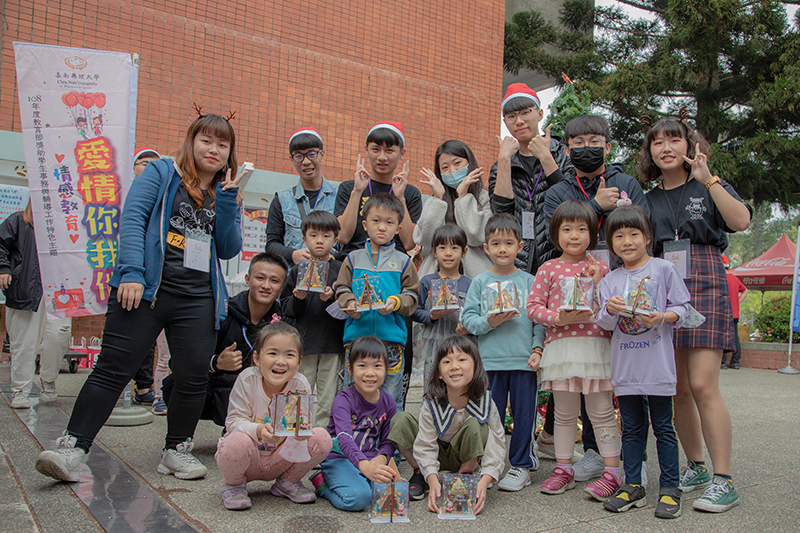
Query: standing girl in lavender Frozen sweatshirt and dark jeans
596,207,690,518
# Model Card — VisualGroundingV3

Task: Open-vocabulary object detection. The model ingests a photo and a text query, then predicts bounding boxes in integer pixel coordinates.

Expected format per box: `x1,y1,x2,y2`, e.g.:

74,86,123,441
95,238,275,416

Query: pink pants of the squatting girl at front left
214,428,332,485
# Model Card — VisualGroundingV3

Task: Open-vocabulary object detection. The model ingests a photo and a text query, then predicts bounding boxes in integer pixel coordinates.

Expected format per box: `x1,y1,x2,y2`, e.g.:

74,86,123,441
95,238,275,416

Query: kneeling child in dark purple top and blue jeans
311,335,397,511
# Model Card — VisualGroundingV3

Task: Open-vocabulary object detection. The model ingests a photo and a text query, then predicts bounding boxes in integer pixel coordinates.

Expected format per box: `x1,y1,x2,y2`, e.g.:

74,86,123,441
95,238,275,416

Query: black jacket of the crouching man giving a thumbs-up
208,291,282,426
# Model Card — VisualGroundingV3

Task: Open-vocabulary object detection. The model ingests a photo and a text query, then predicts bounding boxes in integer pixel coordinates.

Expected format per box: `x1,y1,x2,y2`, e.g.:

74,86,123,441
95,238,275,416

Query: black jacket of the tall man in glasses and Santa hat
489,138,574,274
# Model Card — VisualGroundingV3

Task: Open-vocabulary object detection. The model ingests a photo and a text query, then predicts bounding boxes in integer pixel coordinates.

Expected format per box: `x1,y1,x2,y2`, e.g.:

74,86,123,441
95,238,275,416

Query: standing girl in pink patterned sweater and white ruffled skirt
527,200,620,502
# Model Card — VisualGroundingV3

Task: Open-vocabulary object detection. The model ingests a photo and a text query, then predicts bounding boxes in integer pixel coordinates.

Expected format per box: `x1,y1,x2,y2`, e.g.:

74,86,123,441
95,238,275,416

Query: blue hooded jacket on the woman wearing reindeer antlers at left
109,159,242,329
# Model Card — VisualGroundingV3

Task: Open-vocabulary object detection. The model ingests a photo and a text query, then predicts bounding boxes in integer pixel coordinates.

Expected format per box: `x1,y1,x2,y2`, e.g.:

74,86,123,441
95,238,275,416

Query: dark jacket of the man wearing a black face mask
544,165,650,242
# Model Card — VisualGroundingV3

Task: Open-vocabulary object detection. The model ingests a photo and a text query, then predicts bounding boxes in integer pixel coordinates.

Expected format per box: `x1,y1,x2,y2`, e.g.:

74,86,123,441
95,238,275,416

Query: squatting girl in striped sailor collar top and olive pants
389,335,506,514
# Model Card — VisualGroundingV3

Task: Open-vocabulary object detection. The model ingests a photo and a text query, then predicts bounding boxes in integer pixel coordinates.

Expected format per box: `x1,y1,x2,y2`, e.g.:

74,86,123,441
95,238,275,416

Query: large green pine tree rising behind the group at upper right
504,0,800,207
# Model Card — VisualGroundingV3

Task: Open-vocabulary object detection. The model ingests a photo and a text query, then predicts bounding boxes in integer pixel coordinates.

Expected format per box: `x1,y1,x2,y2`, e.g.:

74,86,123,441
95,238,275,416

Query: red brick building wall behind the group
0,0,505,338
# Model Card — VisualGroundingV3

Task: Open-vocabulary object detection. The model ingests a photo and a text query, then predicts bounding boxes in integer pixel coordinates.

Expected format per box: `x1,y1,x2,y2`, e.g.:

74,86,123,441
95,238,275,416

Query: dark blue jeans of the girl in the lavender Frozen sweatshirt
617,395,680,488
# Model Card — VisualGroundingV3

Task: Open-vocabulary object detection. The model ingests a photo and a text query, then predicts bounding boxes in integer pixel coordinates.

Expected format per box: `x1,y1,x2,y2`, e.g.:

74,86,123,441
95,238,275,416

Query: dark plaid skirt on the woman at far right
674,244,734,351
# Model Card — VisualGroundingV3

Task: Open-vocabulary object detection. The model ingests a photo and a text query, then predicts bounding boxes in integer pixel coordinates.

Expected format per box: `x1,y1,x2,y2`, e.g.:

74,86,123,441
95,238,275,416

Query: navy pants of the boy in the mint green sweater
486,370,539,468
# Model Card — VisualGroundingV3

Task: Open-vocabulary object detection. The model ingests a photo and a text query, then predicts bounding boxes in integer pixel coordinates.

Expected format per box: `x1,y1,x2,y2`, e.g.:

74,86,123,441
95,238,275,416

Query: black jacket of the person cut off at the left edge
0,211,42,311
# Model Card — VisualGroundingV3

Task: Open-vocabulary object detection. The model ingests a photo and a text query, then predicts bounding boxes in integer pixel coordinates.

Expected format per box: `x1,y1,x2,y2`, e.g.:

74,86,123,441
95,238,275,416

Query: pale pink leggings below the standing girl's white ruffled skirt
553,391,620,464
